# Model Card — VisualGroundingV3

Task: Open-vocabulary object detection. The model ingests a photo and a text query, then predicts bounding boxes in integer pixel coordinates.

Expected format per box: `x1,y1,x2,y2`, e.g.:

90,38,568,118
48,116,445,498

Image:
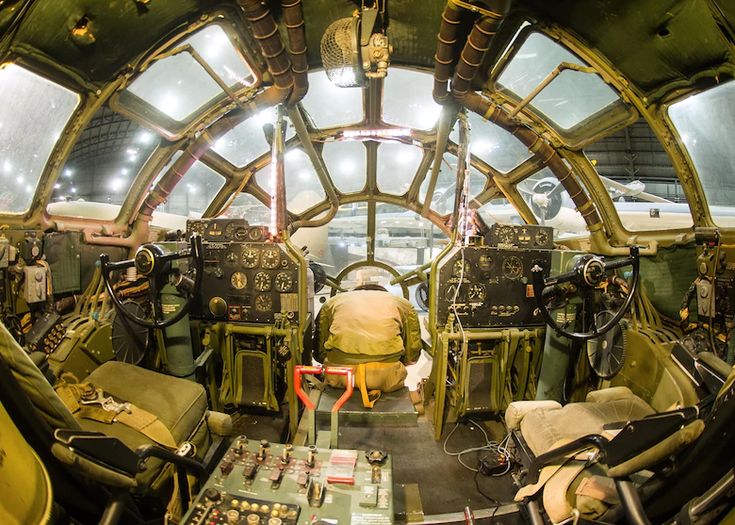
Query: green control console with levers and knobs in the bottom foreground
182,436,393,525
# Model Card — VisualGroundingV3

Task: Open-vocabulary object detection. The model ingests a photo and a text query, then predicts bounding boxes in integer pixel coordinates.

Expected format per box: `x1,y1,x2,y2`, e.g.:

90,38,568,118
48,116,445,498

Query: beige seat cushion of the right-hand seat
521,396,654,456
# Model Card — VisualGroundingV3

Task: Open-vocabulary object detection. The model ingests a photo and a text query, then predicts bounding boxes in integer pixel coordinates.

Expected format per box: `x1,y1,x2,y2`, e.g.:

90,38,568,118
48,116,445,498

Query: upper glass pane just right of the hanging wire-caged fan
383,68,441,129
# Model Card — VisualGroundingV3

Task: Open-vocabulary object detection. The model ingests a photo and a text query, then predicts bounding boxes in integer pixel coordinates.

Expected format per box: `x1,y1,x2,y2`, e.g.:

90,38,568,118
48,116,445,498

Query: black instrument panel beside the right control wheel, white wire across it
437,246,551,328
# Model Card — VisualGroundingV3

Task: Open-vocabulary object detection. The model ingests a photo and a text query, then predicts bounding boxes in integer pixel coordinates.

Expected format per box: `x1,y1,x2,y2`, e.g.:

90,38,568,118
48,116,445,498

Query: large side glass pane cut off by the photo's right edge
669,81,735,227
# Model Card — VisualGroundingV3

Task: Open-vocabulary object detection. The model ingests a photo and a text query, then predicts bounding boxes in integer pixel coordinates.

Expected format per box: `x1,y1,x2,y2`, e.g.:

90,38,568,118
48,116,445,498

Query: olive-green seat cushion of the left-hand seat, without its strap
79,361,208,488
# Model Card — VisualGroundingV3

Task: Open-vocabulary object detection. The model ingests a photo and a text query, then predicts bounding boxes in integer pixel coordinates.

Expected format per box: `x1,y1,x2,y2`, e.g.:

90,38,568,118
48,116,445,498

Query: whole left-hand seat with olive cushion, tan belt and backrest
0,324,226,520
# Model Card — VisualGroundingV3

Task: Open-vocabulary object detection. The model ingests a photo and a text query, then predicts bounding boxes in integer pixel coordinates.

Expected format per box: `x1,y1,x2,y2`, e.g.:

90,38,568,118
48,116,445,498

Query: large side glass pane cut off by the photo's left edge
0,64,79,213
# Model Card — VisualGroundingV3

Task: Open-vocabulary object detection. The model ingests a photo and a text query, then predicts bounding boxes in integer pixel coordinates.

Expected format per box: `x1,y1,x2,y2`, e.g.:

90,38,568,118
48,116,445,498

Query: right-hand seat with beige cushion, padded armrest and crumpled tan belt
505,386,704,522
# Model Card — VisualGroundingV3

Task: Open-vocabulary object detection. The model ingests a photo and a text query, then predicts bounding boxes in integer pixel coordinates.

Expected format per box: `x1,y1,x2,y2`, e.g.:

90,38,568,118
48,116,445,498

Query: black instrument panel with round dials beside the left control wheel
187,219,300,323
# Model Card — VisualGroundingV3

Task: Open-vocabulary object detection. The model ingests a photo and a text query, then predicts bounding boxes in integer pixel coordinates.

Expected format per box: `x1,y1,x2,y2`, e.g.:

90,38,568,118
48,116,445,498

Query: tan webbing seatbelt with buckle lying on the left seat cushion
55,382,177,449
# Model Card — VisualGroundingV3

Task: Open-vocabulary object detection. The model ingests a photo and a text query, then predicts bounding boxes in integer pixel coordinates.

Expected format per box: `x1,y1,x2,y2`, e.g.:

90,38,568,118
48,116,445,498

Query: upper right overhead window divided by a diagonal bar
498,33,619,130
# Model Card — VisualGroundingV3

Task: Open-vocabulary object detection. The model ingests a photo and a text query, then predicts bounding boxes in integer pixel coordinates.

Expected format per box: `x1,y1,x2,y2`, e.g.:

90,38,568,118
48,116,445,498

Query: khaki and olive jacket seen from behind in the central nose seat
314,290,421,364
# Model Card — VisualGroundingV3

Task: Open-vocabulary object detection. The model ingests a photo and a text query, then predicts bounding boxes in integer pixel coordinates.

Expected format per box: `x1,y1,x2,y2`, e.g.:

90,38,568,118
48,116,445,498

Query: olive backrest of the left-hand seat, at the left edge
0,323,81,430
